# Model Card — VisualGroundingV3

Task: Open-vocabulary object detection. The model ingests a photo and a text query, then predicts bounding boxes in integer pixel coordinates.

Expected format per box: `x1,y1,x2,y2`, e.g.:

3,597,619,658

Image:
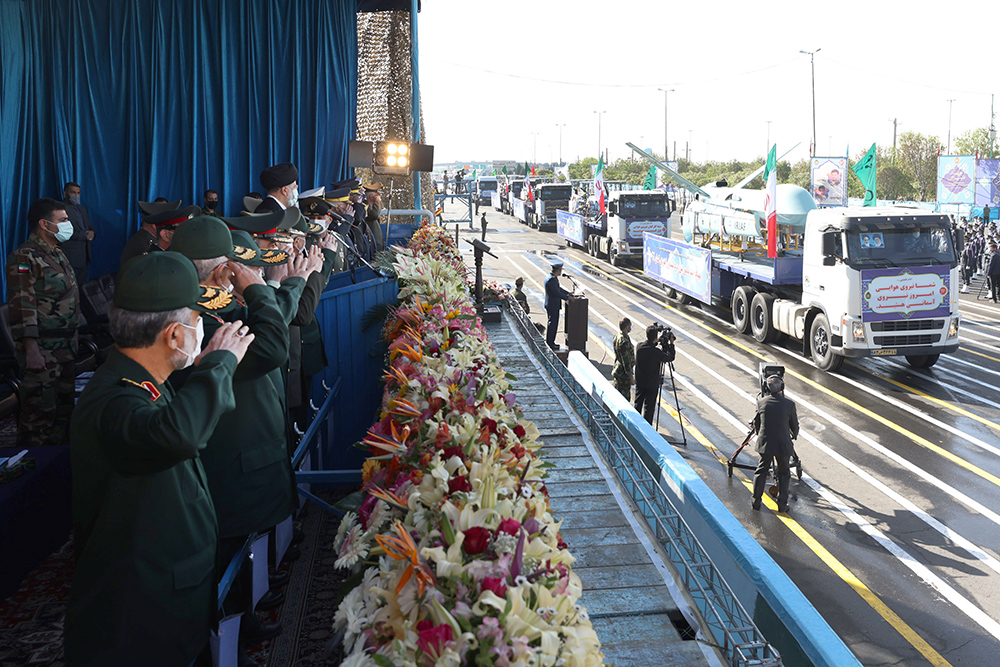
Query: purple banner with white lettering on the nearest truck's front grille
861,266,951,322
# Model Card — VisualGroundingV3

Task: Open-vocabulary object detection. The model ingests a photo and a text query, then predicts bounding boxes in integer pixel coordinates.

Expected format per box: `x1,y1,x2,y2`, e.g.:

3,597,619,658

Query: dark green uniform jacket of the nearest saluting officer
65,349,236,667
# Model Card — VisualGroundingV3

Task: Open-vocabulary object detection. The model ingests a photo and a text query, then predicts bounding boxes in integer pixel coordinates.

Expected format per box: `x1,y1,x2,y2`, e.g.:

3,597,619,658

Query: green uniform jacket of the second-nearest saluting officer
196,278,305,538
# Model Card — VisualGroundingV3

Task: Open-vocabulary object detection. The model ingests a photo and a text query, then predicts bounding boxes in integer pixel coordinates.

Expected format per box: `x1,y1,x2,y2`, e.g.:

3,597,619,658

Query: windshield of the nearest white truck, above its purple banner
847,224,957,268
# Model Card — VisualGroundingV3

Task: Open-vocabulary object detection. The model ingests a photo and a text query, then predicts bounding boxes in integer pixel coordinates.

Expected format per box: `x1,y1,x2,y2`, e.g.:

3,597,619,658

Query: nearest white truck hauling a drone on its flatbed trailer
643,184,961,372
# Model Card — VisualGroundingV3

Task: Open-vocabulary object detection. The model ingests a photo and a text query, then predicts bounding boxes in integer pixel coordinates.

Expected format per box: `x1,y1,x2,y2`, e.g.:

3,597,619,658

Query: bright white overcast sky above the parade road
418,0,1000,168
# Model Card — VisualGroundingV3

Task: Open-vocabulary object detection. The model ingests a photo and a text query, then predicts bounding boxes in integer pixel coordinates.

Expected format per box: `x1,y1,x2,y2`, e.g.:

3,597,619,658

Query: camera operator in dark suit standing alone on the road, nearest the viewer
752,375,799,512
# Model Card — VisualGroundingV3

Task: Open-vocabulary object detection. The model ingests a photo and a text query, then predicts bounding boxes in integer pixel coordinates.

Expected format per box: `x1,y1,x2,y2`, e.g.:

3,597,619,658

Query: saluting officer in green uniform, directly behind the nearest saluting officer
171,217,307,643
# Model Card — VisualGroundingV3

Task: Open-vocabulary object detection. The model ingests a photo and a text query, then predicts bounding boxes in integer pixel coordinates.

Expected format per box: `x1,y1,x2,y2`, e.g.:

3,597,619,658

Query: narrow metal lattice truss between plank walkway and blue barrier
505,301,782,667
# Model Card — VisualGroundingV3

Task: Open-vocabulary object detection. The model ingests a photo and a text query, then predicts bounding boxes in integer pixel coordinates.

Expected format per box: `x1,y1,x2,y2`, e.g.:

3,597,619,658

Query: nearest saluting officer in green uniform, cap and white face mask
65,253,253,667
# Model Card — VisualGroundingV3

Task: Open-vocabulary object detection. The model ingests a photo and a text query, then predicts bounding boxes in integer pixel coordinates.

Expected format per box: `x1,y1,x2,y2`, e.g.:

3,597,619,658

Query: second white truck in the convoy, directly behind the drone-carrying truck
556,190,673,266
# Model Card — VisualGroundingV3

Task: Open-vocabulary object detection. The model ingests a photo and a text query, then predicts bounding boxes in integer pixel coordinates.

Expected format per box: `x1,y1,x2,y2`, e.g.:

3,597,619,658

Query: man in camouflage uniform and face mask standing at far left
7,199,80,447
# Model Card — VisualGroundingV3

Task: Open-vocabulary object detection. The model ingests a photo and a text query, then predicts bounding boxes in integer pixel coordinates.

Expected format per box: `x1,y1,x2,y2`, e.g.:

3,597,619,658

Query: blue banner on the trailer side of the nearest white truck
642,232,712,303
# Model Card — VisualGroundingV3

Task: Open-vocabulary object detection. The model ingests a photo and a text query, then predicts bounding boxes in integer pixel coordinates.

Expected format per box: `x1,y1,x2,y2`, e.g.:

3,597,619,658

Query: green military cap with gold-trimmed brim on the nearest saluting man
114,252,233,313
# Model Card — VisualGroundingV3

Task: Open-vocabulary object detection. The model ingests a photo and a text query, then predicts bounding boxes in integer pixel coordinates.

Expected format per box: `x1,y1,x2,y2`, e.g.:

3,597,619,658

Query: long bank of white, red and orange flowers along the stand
334,226,603,667
